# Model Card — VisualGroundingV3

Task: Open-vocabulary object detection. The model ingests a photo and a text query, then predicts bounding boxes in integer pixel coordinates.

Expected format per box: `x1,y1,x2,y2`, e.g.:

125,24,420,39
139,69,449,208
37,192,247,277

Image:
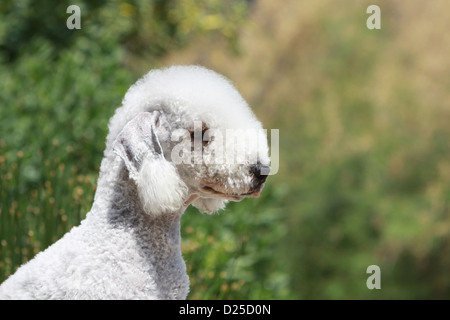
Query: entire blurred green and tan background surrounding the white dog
0,0,450,299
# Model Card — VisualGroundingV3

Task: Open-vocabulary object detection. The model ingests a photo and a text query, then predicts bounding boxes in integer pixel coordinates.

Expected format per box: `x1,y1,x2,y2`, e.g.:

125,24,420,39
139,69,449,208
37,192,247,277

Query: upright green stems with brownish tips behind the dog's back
0,140,96,281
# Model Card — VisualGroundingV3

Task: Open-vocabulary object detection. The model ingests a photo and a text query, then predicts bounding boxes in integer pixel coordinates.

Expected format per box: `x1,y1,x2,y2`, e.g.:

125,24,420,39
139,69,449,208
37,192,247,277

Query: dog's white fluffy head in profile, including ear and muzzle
110,67,269,214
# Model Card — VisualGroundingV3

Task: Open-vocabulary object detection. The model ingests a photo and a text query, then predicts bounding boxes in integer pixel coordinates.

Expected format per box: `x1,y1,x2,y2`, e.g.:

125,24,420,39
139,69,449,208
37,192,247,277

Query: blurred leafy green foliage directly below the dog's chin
181,184,294,299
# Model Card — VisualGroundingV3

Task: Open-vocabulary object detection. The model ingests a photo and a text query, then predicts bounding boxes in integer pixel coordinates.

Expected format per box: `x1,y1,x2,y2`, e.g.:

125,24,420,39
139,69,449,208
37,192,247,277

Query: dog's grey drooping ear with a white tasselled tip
113,111,187,215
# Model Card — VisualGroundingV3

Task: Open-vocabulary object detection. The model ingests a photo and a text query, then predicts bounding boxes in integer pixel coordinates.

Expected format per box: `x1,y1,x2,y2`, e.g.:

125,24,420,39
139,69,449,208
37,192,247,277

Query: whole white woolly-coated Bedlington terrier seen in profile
0,66,269,299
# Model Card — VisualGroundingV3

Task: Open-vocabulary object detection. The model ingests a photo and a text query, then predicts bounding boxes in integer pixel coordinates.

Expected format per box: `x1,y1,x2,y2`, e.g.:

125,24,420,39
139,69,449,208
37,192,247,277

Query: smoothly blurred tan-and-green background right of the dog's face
225,1,450,299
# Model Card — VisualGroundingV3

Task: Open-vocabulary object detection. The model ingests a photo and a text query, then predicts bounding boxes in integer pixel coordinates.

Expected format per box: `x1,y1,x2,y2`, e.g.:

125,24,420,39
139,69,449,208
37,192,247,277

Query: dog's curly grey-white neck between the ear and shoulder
86,155,190,299
